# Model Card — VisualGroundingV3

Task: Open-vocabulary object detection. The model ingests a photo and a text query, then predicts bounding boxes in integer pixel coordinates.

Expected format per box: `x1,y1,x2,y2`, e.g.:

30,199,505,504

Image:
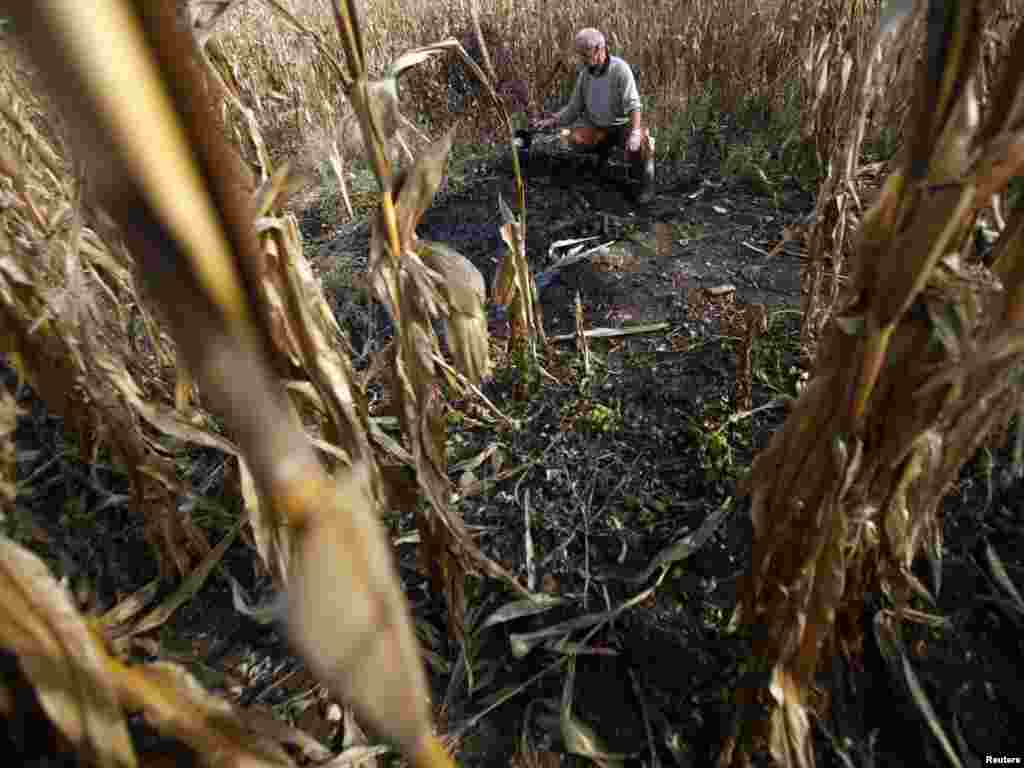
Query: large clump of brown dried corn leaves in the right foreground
720,2,1024,767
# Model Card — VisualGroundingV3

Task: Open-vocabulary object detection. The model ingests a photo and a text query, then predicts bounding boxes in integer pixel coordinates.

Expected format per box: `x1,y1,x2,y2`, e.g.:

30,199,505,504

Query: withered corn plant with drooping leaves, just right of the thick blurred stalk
343,30,522,643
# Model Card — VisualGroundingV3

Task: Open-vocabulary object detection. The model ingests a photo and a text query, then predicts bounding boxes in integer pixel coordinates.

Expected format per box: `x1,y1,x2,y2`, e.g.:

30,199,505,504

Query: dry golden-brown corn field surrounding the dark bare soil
0,0,1024,768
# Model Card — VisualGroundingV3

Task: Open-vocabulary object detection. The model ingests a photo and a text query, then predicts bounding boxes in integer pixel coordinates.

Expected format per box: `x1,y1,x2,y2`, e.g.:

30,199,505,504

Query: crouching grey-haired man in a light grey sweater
537,28,654,203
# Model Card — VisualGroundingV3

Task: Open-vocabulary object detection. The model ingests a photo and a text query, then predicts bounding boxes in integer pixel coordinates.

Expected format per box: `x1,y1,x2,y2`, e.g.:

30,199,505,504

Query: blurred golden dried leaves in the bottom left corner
0,537,307,768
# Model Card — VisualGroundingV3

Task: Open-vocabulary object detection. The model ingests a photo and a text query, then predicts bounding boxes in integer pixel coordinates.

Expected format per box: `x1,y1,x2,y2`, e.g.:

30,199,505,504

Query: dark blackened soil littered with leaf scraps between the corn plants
8,135,1024,766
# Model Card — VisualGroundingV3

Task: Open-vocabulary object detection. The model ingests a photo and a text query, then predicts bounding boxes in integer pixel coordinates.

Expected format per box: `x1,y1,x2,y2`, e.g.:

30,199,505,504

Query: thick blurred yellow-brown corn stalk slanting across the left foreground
2,0,451,766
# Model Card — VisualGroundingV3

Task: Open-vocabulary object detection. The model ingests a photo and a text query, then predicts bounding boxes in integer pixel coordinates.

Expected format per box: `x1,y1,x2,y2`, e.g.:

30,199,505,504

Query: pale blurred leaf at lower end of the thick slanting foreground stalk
288,465,429,755
